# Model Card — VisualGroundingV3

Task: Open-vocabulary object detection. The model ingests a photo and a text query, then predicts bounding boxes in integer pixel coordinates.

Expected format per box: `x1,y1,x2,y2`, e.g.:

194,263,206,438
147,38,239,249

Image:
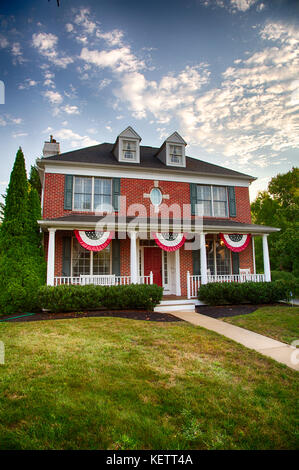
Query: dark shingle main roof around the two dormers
42,143,255,180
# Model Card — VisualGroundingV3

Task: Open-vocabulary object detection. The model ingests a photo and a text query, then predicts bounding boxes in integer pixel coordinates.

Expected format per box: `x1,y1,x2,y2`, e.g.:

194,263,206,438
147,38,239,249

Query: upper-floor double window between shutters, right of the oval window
197,184,228,217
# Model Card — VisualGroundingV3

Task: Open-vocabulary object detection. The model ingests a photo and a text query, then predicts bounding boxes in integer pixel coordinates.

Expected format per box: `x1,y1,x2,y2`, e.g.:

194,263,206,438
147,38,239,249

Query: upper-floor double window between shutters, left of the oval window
73,176,112,212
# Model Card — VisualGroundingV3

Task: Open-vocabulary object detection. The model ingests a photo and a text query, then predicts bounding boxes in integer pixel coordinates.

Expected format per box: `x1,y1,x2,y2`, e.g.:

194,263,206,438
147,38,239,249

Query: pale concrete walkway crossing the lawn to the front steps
167,311,299,370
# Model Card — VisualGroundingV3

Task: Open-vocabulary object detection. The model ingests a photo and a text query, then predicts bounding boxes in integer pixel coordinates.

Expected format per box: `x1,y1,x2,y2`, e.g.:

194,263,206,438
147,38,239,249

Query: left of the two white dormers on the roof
113,126,141,163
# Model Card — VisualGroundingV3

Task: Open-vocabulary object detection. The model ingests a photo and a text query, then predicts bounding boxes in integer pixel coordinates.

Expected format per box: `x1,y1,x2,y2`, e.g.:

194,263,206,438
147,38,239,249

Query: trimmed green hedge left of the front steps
38,284,163,312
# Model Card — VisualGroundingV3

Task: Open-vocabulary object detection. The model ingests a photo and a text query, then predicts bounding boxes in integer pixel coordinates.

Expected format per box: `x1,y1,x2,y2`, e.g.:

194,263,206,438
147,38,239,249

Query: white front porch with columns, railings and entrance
47,227,271,299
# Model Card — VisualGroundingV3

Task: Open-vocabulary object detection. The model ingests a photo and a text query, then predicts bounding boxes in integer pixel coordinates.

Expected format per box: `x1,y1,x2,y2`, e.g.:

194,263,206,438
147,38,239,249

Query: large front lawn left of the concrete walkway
0,318,299,449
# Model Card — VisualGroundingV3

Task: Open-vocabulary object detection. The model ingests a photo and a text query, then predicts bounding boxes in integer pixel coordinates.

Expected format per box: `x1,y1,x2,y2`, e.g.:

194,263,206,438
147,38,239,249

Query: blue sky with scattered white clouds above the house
0,0,299,197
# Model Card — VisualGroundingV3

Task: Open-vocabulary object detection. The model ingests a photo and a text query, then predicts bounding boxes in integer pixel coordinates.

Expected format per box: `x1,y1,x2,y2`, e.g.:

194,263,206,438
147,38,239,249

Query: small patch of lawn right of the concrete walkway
222,307,299,344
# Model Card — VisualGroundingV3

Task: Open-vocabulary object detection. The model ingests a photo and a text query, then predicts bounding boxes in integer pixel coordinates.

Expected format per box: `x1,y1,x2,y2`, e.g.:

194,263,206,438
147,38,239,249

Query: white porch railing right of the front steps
187,271,265,299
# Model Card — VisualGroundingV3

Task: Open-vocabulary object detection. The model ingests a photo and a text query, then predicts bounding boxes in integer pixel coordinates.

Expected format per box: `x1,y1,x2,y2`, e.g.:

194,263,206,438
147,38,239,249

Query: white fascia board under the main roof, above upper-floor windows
44,162,251,188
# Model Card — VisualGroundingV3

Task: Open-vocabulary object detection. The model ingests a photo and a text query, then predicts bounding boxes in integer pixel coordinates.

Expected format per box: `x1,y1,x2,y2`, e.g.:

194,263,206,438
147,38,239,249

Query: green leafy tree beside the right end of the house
251,167,299,276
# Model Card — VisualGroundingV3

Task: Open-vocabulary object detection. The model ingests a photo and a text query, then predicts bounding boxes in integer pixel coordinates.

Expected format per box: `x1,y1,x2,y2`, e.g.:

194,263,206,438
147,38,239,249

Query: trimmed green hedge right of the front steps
198,280,299,305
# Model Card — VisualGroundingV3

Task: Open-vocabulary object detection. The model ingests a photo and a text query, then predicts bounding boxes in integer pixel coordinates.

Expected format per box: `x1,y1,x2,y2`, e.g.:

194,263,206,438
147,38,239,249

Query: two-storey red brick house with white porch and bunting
38,127,278,309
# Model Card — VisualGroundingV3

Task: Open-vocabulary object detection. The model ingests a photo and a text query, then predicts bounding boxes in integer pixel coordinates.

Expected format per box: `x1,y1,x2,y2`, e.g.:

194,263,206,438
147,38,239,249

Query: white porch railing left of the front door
54,272,153,286
